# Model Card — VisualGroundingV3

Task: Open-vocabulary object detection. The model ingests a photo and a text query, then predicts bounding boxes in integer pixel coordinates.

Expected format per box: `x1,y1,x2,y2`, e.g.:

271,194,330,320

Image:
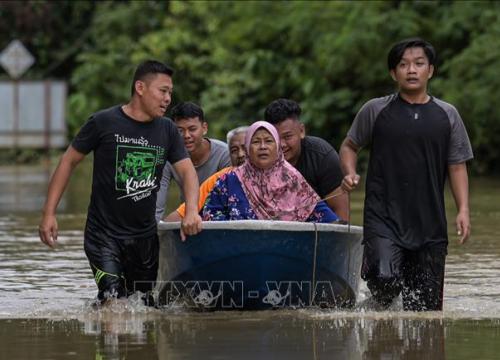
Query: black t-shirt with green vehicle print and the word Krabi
71,105,188,239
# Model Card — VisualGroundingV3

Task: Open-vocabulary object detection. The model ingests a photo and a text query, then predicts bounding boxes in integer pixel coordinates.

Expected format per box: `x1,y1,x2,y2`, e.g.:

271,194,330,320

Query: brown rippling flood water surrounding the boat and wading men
0,161,500,359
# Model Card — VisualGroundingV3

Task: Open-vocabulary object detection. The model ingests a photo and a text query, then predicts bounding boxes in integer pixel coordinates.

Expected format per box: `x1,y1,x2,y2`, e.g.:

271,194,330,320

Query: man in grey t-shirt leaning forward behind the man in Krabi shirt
156,102,231,222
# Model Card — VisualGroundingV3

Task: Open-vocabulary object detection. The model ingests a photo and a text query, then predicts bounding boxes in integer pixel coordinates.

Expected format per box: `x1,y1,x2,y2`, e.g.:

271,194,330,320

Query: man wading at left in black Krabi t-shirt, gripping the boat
39,61,201,300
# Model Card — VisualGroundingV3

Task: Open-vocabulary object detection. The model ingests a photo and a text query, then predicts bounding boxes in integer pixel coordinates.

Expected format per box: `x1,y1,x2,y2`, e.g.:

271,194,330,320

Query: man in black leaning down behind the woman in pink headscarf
264,99,349,220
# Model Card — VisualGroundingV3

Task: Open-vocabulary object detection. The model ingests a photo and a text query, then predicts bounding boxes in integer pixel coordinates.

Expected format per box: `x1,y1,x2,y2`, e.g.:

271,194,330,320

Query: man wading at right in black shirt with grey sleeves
340,38,473,311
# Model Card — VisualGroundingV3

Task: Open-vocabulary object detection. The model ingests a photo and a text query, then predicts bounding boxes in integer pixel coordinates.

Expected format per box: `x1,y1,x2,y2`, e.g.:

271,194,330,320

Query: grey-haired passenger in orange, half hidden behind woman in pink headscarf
164,126,248,222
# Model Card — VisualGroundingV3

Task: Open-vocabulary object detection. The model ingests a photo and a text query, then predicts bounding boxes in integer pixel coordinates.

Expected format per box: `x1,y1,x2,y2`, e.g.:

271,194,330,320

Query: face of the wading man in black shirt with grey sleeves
391,47,434,93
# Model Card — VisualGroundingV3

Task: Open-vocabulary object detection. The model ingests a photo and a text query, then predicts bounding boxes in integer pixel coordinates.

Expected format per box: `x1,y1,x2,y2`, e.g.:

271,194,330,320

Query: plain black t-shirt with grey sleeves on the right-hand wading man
347,94,473,250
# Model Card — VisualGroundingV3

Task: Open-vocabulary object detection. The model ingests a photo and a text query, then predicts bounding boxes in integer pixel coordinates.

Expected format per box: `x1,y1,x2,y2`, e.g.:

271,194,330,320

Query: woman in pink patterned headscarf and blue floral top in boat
202,121,338,222
